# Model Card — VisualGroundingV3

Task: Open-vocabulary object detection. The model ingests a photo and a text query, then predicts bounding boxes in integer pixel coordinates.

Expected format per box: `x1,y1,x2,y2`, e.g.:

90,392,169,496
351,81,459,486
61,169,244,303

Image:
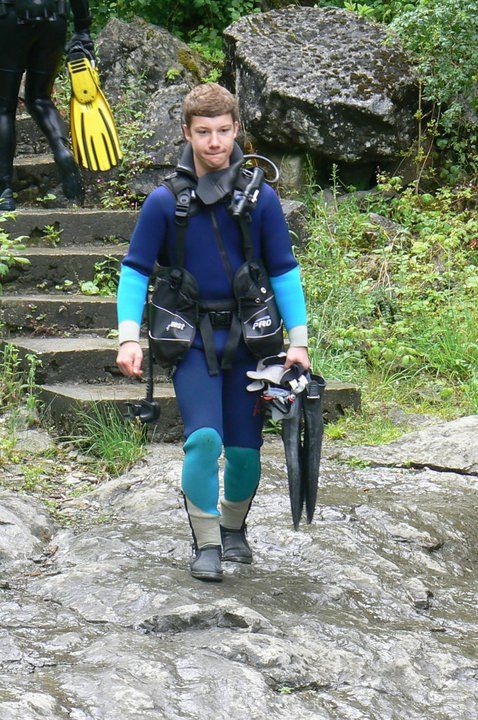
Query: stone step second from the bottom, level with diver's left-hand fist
0,334,168,384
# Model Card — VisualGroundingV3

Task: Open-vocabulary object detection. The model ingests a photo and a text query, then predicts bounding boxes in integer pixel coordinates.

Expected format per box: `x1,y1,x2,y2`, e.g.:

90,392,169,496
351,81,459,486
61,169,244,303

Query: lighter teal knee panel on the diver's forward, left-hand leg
182,428,222,515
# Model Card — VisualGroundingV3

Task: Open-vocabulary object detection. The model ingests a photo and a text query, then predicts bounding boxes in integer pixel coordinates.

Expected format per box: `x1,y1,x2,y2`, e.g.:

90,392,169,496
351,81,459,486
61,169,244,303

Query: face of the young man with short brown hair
183,113,239,177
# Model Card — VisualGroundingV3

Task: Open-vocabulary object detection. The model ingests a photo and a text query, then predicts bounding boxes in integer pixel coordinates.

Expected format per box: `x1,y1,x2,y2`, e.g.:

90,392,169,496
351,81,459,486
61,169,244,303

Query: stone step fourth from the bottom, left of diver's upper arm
4,244,128,291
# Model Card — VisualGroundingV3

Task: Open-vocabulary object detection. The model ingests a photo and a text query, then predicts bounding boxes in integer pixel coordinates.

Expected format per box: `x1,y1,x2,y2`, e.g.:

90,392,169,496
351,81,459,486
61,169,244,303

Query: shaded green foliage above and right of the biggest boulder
91,0,478,183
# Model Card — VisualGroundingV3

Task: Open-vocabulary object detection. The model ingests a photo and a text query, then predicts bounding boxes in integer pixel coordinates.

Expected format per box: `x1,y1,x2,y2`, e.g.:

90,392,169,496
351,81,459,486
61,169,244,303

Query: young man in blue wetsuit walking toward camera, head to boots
117,83,310,581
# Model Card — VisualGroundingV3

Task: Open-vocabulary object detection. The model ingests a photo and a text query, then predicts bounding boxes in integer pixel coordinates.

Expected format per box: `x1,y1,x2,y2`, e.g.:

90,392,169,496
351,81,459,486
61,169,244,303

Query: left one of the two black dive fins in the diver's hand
282,395,304,530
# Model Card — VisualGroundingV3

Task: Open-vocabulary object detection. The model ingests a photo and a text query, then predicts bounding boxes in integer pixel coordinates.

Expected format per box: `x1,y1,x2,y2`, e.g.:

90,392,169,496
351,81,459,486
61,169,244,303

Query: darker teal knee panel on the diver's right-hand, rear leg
224,447,261,502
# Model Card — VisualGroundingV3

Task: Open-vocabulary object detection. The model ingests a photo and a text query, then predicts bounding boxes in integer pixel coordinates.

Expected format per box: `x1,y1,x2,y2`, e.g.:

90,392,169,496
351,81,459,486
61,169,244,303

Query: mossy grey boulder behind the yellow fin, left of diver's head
97,18,210,194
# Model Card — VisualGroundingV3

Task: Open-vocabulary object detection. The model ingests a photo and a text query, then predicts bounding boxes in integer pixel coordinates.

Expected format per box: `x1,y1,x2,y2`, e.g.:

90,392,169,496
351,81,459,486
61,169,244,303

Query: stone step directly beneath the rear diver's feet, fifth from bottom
2,207,138,247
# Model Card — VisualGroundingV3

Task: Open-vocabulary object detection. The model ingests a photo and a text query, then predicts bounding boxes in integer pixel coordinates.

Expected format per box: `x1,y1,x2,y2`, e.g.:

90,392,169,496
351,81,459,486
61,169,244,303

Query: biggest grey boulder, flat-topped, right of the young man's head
225,6,418,163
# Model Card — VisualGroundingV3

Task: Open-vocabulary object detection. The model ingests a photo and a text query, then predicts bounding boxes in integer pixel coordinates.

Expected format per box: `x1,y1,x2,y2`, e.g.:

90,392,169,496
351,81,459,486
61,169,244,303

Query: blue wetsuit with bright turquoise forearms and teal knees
118,163,306,546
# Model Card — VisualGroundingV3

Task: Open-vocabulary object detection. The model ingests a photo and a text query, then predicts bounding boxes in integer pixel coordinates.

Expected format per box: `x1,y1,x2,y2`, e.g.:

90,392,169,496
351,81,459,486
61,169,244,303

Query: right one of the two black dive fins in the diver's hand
301,375,325,523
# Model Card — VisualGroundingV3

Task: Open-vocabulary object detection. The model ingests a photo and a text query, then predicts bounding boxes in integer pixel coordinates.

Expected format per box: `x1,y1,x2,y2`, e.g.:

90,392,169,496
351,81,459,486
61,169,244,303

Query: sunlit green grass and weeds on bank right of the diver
300,179,478,410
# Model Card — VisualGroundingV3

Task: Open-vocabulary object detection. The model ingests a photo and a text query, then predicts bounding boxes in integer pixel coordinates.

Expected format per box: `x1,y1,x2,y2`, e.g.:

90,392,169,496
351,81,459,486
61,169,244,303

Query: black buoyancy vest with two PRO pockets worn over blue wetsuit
148,145,283,375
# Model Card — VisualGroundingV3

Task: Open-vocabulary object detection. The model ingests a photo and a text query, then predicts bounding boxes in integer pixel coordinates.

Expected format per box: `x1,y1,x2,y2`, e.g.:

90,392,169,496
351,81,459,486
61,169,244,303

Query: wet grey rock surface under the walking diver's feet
0,438,478,720
